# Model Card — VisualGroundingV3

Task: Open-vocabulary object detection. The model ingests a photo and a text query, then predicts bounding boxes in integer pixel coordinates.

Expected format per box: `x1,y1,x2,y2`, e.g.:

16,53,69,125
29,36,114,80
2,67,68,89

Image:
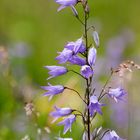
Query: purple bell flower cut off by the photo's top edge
55,0,78,11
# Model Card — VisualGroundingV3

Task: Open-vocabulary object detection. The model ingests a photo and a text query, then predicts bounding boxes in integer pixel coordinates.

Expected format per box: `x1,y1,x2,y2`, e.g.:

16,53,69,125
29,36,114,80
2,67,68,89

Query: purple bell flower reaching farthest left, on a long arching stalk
41,83,65,99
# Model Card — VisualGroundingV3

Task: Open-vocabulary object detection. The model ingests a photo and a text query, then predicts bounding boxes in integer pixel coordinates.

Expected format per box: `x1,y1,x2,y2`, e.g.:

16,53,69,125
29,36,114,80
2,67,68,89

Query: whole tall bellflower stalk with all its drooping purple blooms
41,0,126,140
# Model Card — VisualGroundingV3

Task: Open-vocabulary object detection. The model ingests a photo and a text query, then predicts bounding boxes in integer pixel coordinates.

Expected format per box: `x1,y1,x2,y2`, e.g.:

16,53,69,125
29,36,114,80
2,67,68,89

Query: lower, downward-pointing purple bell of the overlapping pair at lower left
58,114,76,134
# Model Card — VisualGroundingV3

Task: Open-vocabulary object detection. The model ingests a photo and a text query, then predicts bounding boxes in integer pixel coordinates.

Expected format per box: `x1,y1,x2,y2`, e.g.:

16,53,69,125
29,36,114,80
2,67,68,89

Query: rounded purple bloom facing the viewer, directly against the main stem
81,65,94,79
